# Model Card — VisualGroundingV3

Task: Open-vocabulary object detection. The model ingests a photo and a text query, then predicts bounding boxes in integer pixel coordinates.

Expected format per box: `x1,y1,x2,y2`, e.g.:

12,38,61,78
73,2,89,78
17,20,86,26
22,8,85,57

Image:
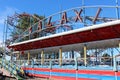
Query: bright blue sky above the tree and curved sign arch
0,0,120,41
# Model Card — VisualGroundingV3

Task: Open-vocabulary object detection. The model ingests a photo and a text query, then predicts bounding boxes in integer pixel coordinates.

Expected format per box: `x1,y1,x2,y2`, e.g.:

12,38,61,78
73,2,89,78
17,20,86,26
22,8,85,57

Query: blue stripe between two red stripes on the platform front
26,70,120,80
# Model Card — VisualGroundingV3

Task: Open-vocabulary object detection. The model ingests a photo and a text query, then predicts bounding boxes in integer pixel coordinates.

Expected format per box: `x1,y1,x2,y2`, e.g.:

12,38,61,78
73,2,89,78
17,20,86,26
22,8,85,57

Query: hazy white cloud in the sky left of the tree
0,7,19,24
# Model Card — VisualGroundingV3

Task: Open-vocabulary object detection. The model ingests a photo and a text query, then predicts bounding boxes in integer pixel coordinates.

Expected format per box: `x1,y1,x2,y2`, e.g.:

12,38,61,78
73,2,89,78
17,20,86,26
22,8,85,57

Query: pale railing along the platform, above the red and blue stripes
14,57,120,70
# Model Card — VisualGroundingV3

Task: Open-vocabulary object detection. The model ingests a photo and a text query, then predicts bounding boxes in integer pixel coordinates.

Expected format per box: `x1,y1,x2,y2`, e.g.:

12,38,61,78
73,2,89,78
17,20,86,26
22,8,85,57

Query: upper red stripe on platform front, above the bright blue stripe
23,68,120,76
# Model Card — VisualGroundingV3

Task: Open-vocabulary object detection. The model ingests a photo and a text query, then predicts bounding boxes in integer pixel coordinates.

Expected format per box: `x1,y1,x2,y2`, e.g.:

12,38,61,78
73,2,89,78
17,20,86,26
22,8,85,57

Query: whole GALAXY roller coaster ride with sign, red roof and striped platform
0,3,120,80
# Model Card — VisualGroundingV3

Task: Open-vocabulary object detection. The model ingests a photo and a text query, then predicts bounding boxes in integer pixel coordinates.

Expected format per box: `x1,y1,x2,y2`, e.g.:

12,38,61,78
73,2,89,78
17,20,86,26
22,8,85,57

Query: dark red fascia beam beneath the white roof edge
11,25,120,51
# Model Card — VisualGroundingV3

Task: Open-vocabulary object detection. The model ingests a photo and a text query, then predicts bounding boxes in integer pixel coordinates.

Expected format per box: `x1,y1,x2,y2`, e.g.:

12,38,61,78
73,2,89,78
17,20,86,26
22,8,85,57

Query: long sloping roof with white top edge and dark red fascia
9,20,120,51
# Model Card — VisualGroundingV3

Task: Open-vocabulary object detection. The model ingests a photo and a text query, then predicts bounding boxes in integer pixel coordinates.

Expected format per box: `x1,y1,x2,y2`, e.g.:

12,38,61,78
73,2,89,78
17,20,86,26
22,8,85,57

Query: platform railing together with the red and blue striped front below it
12,57,119,80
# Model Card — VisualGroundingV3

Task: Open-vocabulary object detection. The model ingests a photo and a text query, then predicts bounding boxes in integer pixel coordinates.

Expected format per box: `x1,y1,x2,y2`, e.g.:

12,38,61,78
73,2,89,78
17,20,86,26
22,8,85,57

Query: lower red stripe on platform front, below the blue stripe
28,74,97,80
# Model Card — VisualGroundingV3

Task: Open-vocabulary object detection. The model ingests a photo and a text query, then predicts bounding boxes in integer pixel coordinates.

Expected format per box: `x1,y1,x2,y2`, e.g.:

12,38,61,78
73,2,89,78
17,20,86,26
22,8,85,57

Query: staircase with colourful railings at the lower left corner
1,59,25,80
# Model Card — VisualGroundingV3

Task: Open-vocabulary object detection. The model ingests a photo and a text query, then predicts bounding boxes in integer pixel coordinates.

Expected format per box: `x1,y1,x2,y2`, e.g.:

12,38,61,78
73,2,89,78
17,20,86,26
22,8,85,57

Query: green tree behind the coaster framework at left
10,12,45,41
